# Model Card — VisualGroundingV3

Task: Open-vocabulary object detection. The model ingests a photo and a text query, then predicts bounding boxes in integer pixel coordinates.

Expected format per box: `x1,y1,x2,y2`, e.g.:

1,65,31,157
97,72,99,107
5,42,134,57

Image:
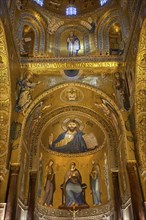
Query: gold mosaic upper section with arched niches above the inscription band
10,0,131,60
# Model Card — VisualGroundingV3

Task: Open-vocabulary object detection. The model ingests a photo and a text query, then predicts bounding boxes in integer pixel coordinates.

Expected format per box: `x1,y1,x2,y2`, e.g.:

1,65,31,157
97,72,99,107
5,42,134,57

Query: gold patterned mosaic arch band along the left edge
0,19,11,179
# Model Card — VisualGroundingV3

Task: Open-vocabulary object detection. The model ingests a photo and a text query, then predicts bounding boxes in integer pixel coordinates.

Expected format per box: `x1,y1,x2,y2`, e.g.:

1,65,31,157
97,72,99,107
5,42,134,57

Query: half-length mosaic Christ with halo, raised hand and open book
49,119,98,154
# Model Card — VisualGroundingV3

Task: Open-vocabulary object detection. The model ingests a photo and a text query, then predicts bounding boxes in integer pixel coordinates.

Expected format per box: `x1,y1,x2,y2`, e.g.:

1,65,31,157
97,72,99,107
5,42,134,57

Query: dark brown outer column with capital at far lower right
127,162,146,220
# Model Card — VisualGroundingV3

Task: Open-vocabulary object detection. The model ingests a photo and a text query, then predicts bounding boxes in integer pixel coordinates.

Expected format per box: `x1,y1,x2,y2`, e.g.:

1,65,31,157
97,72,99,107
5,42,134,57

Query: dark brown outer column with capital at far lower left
5,164,20,220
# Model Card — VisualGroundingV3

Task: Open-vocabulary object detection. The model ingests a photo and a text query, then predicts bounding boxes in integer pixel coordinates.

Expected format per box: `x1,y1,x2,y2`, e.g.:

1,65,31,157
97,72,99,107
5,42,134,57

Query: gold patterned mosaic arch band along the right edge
135,18,146,169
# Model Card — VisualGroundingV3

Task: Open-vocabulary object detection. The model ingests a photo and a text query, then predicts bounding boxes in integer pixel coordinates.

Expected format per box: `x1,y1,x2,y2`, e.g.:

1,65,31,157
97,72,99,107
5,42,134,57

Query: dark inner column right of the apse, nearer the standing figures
112,172,122,220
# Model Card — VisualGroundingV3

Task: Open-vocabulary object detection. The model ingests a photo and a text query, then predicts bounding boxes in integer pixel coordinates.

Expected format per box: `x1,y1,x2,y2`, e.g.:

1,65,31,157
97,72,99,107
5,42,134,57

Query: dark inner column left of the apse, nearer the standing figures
28,172,37,220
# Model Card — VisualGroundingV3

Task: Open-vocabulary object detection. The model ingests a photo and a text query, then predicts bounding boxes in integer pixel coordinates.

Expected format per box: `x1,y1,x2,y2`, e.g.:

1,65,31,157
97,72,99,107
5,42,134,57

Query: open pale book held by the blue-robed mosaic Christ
83,133,98,150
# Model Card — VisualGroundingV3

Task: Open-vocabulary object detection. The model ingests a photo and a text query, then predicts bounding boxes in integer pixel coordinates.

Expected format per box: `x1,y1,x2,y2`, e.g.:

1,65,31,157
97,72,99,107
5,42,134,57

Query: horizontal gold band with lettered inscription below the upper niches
21,60,124,72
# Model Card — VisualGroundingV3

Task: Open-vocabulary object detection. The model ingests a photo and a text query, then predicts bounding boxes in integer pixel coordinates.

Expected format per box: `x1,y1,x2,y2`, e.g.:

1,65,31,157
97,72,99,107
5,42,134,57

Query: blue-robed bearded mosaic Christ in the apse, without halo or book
49,120,87,153
